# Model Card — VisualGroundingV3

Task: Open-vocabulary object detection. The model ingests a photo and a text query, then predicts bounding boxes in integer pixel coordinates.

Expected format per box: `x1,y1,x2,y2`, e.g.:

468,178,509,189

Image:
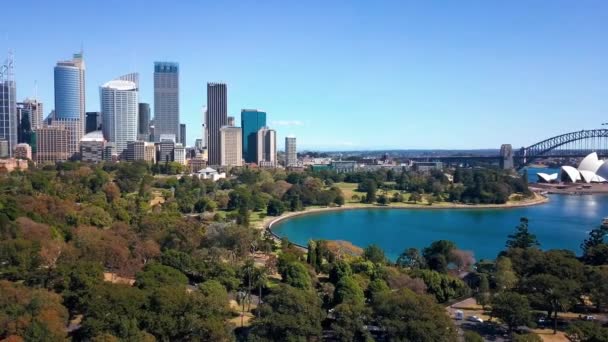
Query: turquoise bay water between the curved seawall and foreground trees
273,195,608,260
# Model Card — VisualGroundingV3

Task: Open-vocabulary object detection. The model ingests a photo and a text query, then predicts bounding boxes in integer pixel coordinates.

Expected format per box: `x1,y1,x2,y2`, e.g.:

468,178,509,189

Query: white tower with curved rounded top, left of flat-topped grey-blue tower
100,80,138,158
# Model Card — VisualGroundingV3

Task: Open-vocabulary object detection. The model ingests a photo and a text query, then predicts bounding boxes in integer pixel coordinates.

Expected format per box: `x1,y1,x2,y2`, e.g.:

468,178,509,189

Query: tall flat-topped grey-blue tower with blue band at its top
154,62,179,142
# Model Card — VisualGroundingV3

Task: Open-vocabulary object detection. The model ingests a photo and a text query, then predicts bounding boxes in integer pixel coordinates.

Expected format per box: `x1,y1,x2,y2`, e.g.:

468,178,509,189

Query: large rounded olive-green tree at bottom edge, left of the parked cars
372,289,458,342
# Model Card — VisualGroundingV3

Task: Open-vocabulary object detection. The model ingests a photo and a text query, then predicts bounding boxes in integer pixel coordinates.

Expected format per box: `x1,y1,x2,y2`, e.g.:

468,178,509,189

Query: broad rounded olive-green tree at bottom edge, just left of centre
249,285,324,341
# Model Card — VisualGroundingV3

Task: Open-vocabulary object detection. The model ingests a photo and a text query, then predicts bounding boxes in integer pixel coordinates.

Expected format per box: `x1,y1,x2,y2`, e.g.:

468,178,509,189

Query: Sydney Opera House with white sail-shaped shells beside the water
536,152,608,183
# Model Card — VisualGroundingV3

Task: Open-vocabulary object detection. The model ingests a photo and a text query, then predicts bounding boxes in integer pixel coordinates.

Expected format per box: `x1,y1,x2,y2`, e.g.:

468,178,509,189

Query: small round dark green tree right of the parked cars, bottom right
492,292,531,332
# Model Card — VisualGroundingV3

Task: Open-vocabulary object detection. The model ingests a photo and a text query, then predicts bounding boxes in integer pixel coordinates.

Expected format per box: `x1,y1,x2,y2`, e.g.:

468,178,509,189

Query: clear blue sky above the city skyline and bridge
0,0,608,149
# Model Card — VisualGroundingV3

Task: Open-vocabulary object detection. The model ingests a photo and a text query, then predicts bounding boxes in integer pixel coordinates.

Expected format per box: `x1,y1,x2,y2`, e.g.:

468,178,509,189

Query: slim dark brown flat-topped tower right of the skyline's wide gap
207,83,228,165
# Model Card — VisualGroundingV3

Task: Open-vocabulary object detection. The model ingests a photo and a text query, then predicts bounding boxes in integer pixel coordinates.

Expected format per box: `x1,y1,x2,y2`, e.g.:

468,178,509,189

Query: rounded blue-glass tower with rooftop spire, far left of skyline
54,53,85,156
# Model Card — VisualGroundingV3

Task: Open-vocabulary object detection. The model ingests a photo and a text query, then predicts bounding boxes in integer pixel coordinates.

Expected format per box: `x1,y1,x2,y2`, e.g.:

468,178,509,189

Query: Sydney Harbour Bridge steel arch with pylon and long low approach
412,128,608,168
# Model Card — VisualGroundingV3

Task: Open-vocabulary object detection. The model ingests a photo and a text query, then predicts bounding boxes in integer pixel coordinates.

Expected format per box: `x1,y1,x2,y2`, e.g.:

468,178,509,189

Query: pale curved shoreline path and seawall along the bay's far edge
255,192,549,234
